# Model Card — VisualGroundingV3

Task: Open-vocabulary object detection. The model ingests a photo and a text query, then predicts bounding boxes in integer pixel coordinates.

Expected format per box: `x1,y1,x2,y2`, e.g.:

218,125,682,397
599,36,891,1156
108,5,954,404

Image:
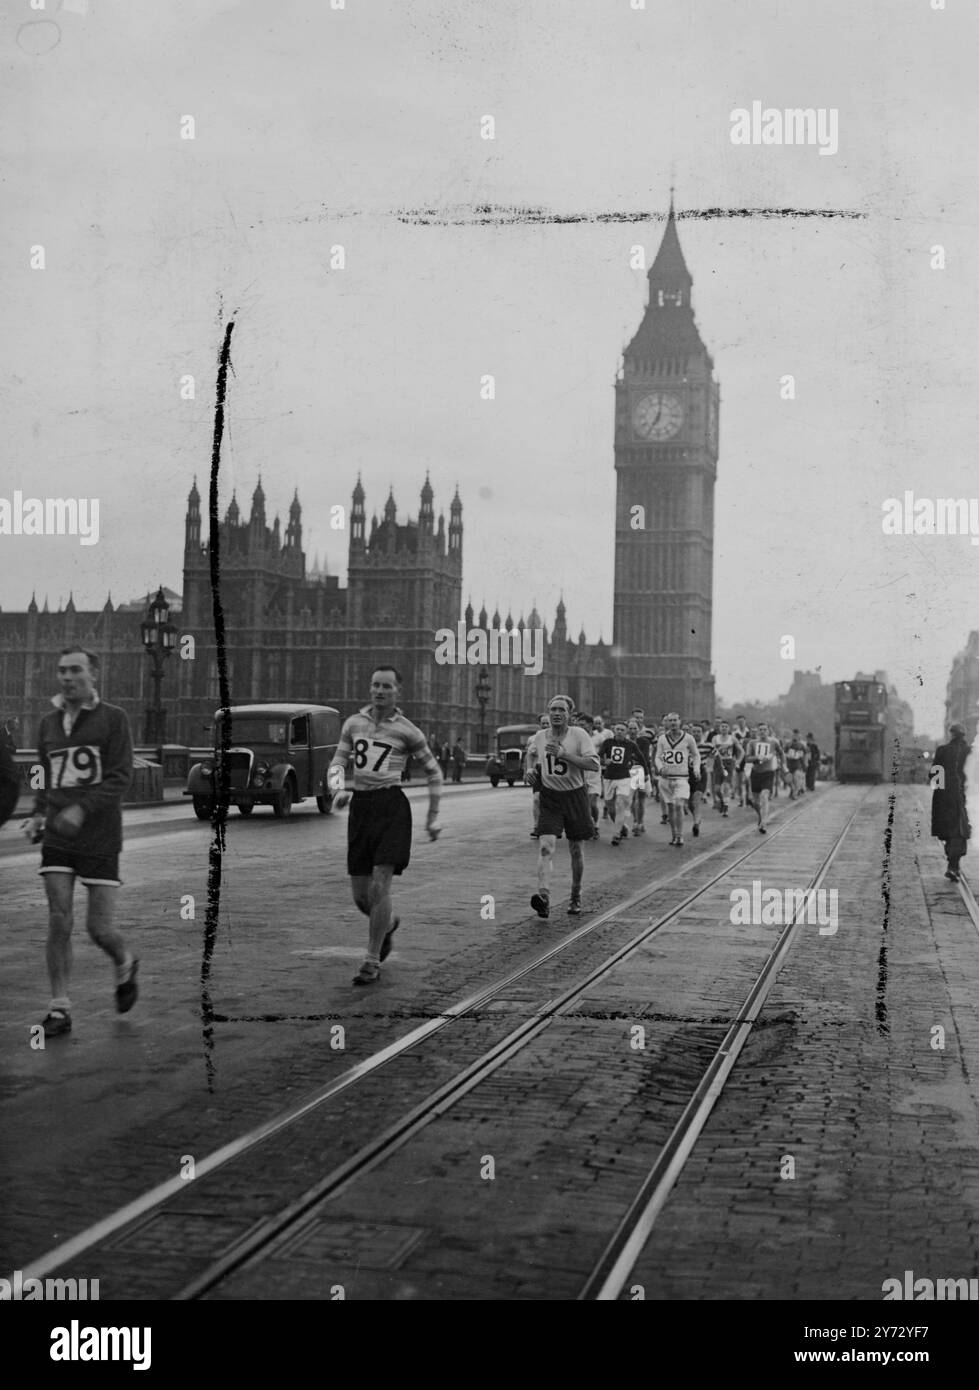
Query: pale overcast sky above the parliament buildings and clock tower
0,0,979,731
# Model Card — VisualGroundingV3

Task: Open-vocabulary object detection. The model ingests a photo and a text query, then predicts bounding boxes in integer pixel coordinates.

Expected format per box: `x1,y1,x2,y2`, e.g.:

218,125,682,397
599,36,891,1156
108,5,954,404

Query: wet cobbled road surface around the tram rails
0,787,979,1300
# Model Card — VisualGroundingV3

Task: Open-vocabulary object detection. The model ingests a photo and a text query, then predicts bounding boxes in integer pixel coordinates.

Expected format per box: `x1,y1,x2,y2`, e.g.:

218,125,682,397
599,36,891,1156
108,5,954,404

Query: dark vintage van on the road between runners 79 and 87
184,705,341,820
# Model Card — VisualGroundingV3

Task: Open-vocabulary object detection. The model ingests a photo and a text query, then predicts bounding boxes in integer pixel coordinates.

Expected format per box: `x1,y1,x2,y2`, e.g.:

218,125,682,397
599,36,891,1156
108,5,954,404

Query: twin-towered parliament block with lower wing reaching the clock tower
171,478,615,749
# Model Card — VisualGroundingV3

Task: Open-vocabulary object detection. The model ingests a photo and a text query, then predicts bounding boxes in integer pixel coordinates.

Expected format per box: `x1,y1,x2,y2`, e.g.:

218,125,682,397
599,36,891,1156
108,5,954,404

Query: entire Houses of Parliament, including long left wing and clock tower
0,206,719,749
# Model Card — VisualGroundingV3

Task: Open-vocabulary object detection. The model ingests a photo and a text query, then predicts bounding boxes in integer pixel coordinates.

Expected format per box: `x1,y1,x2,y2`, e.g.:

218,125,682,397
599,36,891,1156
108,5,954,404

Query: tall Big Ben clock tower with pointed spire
612,200,719,719
